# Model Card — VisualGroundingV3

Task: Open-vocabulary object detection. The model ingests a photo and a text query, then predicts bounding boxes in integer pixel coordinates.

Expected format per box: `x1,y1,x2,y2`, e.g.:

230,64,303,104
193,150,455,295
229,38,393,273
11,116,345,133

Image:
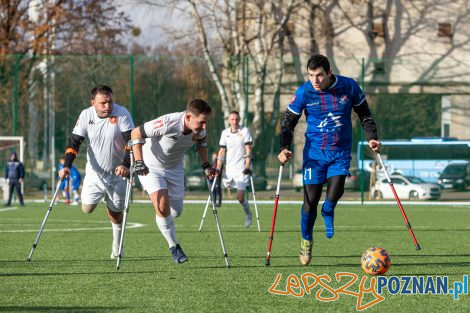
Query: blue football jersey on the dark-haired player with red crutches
288,75,366,150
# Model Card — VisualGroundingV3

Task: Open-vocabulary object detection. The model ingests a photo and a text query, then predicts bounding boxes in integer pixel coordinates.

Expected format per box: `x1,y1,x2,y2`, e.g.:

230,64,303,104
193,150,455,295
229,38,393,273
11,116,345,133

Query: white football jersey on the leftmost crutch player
72,103,134,176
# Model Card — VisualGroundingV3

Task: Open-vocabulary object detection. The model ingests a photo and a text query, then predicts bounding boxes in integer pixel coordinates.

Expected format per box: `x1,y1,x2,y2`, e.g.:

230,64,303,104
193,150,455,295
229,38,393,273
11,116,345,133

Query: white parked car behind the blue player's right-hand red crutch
370,175,441,200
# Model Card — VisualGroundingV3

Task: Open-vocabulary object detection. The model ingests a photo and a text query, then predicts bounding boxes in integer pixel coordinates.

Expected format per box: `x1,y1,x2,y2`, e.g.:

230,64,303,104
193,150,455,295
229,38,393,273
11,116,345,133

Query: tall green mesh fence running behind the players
0,55,470,199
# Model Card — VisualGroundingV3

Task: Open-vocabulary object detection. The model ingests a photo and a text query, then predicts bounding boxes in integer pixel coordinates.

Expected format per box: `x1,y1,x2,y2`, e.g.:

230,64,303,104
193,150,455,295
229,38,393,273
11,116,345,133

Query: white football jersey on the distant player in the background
219,126,253,172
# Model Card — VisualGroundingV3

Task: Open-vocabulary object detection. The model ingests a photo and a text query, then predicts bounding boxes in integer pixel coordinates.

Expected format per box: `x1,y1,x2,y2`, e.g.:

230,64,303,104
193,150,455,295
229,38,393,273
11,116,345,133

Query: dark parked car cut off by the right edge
437,162,470,190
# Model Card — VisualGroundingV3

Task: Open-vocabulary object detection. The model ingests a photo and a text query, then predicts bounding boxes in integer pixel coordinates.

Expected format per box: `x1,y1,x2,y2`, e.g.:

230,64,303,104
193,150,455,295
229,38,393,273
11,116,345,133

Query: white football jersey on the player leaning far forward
142,111,206,173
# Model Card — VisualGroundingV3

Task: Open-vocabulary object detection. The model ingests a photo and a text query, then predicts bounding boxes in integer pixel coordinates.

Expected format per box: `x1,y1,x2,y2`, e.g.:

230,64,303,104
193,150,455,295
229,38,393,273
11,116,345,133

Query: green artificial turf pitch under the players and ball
0,201,470,313
